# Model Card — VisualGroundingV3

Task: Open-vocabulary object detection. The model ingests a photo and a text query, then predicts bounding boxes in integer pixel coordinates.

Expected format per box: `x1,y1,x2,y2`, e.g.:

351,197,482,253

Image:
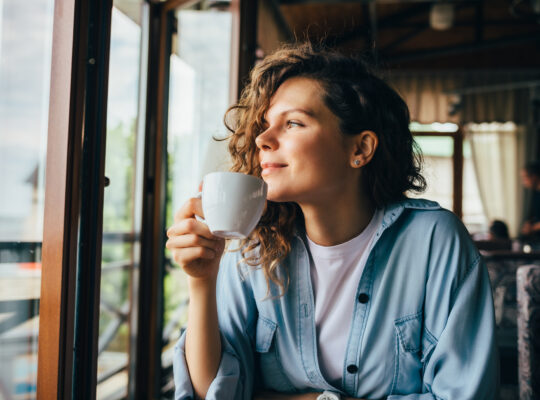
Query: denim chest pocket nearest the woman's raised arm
255,316,296,393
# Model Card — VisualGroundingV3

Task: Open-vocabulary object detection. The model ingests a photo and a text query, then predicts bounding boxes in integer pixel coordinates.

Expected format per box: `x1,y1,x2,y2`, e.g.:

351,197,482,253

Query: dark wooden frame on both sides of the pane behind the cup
130,0,257,399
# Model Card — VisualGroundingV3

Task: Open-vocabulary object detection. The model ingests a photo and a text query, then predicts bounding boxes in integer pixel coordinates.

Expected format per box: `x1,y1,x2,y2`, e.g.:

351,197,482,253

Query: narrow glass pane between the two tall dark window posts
97,0,143,399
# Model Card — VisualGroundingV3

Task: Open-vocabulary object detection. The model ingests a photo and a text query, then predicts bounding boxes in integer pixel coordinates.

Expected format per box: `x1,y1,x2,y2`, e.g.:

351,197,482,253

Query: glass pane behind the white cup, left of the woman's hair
162,5,231,397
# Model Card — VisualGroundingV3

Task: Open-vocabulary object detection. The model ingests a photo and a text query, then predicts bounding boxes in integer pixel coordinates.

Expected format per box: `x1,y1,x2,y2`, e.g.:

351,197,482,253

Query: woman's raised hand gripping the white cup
166,197,225,281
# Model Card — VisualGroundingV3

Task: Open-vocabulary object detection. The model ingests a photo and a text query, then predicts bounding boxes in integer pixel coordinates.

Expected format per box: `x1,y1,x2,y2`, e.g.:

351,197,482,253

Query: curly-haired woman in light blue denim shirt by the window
167,45,497,400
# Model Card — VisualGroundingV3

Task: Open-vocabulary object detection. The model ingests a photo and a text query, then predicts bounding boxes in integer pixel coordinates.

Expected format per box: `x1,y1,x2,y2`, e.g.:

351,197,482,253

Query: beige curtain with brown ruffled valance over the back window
386,70,540,235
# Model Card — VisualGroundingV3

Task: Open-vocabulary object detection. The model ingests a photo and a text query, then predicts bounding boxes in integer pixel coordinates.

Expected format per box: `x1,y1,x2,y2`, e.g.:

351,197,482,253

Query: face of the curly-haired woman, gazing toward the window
255,77,358,204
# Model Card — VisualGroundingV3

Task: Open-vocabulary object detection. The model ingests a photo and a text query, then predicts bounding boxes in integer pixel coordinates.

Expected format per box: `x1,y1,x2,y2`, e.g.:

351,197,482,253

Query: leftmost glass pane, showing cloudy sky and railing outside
0,0,54,399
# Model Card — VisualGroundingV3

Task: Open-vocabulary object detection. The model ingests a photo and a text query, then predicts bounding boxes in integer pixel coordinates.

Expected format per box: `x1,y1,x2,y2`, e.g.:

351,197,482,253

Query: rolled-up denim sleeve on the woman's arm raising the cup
173,253,257,400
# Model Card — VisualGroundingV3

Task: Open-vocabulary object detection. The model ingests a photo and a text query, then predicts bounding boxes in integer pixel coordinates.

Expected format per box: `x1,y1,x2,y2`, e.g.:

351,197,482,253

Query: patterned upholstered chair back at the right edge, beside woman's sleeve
517,265,540,400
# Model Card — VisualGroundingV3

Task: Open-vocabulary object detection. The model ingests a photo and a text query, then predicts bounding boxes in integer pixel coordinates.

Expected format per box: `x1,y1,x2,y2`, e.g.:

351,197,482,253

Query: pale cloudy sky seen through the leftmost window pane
0,0,53,234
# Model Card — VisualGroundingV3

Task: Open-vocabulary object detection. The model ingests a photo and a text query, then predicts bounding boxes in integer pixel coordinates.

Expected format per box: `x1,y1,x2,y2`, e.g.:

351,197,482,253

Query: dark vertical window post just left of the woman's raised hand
129,3,171,399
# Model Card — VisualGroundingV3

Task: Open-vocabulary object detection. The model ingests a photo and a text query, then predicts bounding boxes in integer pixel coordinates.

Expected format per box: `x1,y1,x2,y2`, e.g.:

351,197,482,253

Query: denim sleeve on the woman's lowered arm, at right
388,234,499,400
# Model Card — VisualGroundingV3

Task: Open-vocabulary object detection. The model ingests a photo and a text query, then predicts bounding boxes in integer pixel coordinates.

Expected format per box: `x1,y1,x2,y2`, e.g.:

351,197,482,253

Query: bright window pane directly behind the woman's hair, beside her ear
410,136,454,210
